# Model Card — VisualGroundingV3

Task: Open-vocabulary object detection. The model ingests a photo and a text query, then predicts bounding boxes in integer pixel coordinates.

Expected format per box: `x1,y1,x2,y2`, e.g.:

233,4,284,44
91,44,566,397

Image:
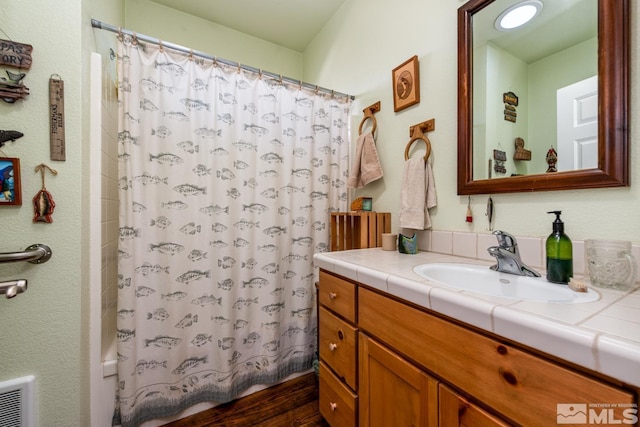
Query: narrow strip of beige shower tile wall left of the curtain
100,55,118,361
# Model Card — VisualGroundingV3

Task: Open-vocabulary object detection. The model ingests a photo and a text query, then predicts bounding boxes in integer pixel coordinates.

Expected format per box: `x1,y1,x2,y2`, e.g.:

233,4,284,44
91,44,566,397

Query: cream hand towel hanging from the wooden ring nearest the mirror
399,157,437,230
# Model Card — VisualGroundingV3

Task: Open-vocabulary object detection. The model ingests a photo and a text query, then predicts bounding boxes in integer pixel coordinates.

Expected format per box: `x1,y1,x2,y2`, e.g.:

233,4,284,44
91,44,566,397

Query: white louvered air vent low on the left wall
0,375,36,427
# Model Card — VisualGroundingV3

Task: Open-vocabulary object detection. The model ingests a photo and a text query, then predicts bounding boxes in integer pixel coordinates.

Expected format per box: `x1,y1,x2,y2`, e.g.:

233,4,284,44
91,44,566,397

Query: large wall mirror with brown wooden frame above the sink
458,0,629,195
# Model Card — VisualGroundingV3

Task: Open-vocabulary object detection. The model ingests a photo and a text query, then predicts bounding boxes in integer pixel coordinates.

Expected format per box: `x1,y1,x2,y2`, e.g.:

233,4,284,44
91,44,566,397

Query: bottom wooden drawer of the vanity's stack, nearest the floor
318,361,358,427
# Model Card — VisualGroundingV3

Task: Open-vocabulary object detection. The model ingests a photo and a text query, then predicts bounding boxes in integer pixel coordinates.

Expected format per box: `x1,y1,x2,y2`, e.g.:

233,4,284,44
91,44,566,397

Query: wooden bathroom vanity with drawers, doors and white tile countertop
314,248,640,427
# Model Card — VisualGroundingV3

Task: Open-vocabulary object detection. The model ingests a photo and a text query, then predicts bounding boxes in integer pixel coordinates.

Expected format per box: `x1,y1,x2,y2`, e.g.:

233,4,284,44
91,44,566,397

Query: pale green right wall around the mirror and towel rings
303,0,640,243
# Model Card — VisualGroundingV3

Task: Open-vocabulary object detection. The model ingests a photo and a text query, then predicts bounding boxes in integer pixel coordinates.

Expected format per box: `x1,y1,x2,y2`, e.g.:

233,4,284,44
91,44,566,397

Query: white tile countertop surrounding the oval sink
314,248,640,387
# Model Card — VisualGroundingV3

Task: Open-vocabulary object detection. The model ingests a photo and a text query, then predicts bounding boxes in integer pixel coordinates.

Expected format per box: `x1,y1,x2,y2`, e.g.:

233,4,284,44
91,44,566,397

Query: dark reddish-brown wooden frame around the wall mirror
458,0,629,195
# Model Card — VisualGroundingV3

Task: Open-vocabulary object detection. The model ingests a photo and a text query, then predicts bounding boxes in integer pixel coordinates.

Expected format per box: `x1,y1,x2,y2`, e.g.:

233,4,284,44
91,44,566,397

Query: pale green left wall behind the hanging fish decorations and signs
0,0,123,427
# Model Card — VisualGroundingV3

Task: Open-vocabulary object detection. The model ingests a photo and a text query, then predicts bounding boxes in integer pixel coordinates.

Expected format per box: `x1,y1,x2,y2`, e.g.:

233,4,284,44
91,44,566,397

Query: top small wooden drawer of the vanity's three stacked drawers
318,270,356,323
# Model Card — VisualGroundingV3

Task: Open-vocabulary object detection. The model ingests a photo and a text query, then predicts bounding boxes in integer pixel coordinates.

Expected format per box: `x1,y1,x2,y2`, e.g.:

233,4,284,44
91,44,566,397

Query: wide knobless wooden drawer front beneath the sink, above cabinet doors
358,288,634,426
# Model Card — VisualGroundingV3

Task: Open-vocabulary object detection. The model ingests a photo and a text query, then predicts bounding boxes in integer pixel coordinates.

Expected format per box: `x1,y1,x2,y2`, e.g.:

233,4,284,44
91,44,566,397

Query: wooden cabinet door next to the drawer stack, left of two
358,334,438,427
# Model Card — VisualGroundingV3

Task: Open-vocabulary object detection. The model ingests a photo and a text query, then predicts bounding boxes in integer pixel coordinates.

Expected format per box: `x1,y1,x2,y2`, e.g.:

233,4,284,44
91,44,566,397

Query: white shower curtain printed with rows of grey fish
114,36,351,426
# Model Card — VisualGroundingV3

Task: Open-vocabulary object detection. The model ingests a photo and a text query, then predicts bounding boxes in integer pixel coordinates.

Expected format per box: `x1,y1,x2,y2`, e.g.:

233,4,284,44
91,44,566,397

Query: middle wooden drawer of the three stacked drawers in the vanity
318,307,358,390
